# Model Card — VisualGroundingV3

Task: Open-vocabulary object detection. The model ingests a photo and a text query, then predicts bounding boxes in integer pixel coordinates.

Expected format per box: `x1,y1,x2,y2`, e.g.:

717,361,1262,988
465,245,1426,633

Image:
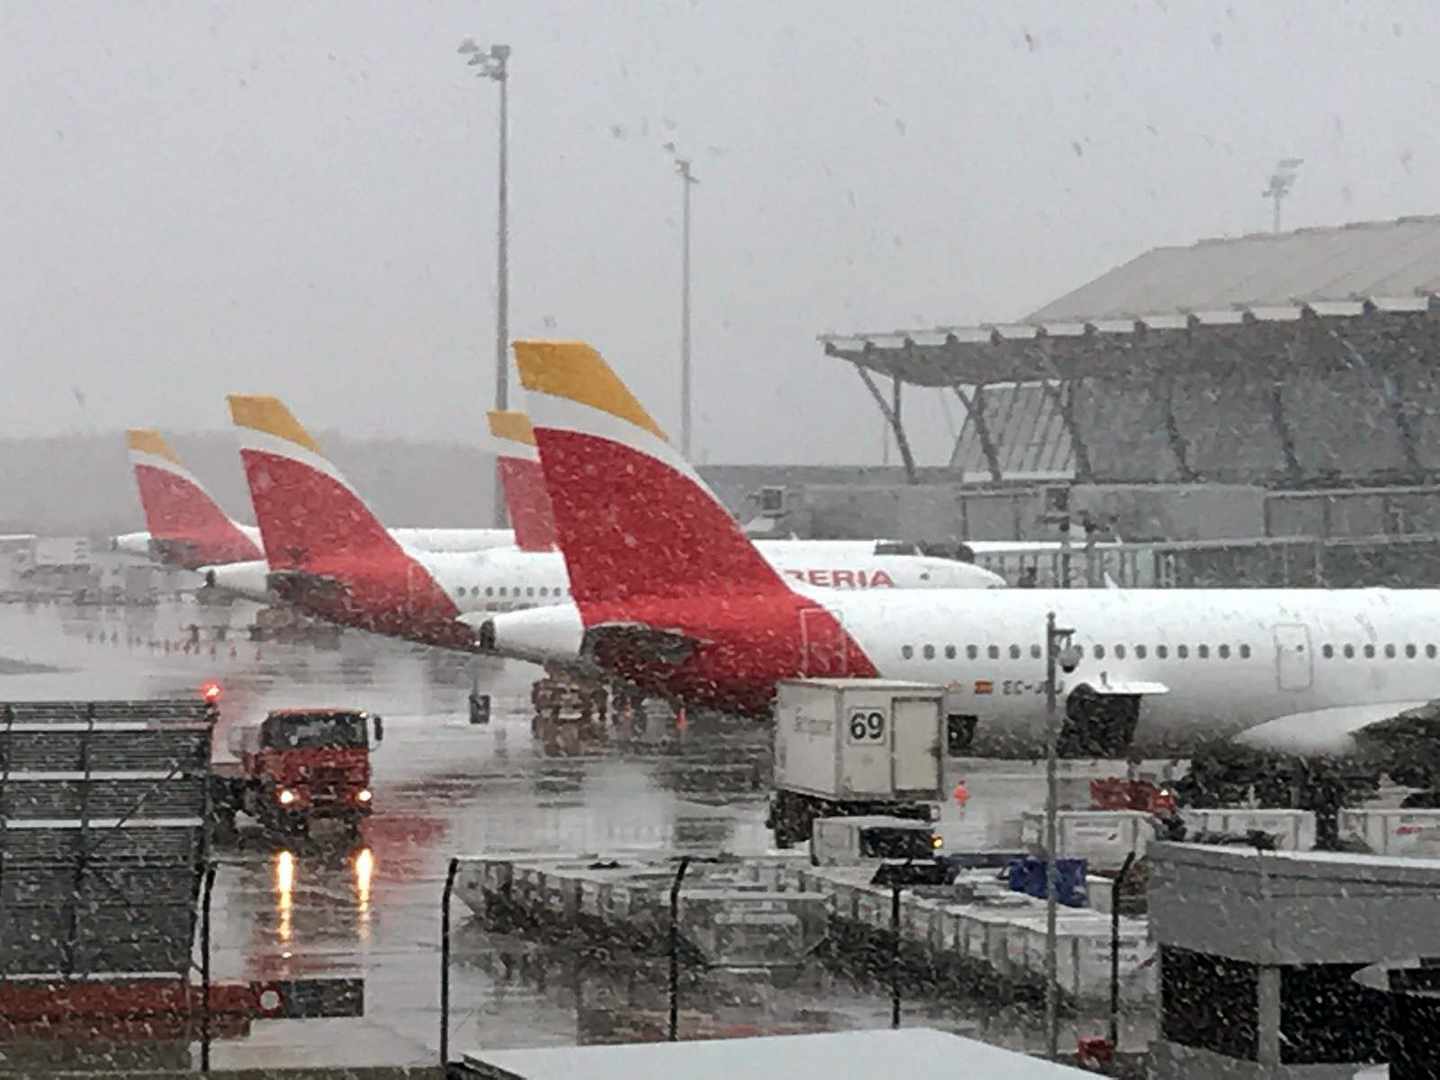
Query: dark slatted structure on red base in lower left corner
0,697,363,1066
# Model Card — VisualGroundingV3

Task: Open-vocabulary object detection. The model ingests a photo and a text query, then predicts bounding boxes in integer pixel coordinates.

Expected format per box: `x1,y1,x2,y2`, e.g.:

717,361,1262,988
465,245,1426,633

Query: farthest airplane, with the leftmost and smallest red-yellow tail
111,428,514,570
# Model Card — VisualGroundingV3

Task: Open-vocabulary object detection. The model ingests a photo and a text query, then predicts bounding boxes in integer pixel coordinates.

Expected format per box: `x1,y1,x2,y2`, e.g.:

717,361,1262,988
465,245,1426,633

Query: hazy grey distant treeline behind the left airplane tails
0,432,495,536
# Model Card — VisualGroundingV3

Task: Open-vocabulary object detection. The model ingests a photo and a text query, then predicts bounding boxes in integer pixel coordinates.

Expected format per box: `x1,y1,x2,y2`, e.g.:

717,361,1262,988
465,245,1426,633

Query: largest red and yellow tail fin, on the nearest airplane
516,341,789,602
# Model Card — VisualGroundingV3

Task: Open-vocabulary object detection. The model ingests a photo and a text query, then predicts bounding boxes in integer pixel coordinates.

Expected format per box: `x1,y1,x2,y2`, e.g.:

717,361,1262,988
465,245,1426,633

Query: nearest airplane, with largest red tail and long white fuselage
464,341,1440,786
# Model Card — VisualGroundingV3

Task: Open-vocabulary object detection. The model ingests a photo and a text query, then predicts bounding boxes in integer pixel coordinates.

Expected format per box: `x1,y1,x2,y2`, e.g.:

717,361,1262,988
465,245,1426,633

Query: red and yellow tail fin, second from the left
228,393,405,570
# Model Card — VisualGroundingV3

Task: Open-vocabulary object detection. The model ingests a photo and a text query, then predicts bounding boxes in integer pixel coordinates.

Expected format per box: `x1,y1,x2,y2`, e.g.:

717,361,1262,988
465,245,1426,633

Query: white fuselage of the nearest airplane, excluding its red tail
829,589,1440,753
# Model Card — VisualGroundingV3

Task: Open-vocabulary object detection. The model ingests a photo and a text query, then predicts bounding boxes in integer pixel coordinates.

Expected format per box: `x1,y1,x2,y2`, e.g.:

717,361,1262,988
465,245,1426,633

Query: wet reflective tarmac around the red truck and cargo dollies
0,602,1148,1067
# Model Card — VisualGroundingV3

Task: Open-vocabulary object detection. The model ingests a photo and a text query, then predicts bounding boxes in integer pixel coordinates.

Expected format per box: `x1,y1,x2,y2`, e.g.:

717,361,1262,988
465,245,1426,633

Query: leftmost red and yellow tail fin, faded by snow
125,428,262,569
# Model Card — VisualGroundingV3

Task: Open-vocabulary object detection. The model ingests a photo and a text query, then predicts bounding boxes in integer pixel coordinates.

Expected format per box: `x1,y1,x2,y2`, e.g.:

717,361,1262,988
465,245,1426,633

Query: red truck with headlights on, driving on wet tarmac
204,684,384,834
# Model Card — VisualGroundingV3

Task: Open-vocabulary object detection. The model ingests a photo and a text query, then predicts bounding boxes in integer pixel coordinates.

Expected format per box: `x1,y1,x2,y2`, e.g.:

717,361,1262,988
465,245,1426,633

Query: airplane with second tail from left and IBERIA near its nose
204,395,1004,649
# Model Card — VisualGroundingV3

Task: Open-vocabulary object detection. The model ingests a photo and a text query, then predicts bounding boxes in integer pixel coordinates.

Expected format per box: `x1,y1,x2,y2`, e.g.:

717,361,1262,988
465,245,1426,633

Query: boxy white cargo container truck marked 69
769,678,945,848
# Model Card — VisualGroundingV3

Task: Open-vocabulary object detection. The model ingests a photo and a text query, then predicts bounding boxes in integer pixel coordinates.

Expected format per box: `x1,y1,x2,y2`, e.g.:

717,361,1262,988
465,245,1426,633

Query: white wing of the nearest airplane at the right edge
1236,701,1440,759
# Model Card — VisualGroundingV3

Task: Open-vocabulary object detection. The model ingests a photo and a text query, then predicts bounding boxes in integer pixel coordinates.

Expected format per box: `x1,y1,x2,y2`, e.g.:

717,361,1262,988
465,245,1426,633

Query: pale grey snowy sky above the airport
0,0,1440,462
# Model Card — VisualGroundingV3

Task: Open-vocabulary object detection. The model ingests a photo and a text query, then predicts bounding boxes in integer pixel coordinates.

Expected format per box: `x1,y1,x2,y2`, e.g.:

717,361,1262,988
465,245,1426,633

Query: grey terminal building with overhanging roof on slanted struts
794,216,1440,585
